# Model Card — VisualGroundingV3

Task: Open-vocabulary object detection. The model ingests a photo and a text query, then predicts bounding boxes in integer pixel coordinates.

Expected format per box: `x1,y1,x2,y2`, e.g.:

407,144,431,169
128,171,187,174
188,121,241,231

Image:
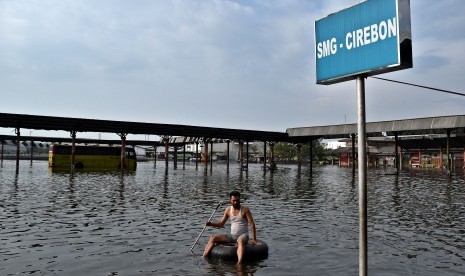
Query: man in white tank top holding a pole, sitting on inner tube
203,191,260,264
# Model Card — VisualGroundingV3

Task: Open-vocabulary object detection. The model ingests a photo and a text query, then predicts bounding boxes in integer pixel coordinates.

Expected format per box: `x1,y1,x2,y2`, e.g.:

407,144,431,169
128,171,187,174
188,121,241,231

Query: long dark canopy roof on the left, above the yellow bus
0,113,288,141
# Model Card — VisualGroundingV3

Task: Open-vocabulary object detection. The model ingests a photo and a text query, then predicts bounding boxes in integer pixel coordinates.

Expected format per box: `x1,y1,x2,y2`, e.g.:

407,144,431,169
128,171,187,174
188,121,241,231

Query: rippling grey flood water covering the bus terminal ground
0,161,465,275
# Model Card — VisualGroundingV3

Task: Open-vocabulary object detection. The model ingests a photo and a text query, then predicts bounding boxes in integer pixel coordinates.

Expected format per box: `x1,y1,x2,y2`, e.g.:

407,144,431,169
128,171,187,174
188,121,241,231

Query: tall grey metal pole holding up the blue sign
357,76,368,276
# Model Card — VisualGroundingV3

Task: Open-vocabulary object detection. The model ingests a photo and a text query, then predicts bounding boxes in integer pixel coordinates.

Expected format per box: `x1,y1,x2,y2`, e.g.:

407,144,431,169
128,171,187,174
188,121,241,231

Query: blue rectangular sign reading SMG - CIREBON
315,0,413,84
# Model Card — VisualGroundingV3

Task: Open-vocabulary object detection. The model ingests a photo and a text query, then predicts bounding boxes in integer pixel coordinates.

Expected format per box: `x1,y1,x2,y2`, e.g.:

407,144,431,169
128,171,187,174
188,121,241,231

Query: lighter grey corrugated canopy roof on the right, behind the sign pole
286,115,465,140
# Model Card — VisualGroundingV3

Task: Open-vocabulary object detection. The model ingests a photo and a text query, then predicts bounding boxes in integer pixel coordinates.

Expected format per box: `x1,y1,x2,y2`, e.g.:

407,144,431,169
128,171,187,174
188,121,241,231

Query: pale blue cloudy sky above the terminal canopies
0,0,465,139
